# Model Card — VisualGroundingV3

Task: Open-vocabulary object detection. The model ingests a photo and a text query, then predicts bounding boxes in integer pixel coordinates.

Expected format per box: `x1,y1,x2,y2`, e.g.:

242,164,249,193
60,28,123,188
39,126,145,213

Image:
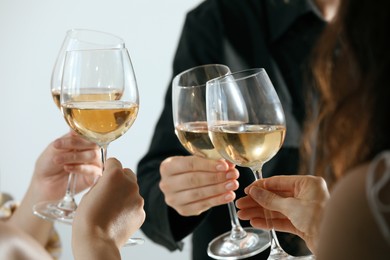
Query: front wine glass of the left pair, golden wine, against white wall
60,47,144,245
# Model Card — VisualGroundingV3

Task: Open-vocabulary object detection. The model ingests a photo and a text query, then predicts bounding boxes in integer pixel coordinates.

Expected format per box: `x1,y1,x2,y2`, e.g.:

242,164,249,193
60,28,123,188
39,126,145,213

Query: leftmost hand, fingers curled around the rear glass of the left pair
31,131,102,202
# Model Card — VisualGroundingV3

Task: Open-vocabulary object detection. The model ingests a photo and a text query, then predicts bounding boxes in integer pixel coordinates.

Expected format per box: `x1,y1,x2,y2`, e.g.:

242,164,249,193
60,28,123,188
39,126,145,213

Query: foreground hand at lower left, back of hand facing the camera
72,158,145,259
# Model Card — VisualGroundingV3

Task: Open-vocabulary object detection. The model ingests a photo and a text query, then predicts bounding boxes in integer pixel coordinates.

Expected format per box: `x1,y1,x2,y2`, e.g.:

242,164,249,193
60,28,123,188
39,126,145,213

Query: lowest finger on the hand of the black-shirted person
174,192,236,216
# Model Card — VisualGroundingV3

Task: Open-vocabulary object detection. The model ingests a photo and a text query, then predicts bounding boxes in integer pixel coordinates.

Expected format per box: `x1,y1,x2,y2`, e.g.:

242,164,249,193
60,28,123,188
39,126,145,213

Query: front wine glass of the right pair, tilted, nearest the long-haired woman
206,68,314,259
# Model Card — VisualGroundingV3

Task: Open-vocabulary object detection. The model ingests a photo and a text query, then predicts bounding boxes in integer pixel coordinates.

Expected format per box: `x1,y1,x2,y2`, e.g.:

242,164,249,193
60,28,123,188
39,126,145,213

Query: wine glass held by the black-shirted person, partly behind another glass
172,64,269,259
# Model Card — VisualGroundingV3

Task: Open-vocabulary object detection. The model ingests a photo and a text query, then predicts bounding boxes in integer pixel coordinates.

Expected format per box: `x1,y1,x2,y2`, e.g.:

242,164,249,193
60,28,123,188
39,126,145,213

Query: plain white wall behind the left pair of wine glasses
0,0,200,260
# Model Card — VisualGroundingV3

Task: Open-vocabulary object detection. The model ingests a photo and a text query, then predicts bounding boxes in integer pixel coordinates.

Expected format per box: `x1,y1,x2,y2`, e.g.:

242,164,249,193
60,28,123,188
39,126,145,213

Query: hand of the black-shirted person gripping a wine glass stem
160,156,239,216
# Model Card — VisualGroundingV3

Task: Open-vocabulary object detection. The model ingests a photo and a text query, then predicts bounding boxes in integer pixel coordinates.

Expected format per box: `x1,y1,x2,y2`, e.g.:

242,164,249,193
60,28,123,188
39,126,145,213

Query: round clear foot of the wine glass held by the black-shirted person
207,228,270,259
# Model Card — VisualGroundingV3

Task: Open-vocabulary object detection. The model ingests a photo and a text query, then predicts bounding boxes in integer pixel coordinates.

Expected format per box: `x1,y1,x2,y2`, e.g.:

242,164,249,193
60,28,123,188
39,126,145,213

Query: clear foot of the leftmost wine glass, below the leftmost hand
33,201,75,225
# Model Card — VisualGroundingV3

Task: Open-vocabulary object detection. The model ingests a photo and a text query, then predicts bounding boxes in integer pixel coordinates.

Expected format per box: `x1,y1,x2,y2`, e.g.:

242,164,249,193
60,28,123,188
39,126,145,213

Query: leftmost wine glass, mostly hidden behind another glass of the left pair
33,29,124,224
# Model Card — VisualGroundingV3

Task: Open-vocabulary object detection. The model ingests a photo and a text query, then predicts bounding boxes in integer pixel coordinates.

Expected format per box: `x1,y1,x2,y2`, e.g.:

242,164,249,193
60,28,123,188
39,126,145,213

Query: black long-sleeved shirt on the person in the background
137,0,325,260
